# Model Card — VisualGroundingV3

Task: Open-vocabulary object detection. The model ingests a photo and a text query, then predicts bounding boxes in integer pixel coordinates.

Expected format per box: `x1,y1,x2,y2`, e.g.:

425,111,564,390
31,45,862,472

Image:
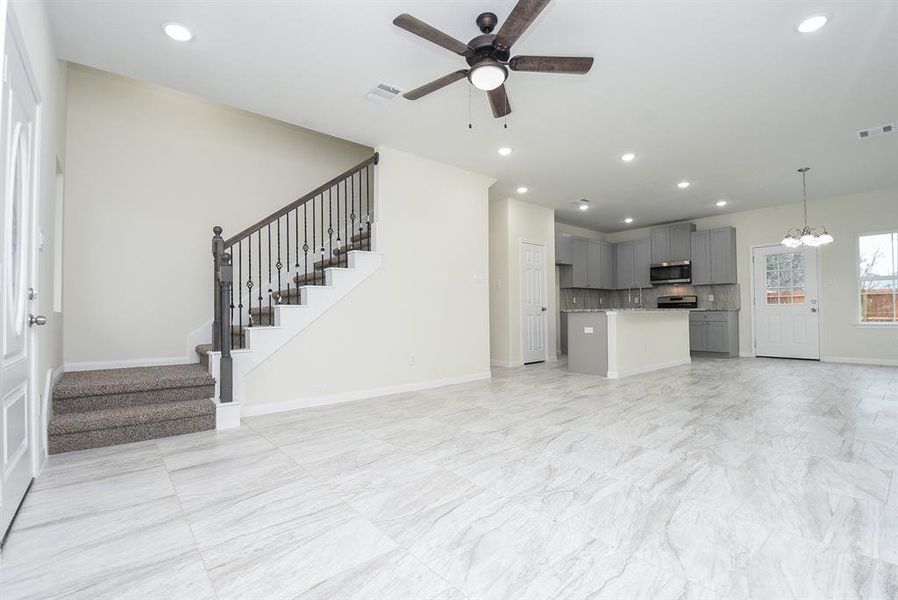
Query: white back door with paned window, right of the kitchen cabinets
752,246,820,359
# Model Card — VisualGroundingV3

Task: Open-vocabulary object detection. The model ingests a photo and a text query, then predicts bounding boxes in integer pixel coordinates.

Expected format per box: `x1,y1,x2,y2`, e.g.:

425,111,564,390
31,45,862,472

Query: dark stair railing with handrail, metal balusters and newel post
212,152,380,403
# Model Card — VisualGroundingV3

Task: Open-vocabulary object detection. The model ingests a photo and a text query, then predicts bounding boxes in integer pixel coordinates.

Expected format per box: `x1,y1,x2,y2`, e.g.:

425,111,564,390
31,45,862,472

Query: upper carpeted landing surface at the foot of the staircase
53,363,215,399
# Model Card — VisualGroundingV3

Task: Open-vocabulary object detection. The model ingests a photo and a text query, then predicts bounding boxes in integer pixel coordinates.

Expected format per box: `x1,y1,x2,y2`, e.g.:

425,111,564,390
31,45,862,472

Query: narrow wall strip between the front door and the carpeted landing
6,0,66,455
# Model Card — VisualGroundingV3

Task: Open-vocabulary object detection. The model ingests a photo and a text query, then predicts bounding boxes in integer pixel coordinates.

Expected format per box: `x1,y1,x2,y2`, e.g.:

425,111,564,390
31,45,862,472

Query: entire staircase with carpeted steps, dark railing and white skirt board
49,154,380,454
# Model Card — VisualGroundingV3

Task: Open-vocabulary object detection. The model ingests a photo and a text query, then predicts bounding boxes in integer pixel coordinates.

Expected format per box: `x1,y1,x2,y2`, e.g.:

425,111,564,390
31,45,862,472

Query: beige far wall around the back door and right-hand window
608,188,898,364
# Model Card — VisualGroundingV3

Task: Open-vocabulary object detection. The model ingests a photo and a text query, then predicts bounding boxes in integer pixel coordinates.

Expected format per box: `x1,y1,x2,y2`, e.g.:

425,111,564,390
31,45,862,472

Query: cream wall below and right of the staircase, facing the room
243,148,494,413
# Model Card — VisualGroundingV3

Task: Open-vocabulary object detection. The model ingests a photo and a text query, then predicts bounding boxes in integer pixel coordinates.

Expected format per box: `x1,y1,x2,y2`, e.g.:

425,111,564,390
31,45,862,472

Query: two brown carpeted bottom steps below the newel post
49,364,215,454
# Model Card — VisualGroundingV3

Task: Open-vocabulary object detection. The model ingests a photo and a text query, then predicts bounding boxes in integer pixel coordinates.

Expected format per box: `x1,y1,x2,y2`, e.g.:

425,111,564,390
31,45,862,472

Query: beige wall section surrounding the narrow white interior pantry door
490,197,557,365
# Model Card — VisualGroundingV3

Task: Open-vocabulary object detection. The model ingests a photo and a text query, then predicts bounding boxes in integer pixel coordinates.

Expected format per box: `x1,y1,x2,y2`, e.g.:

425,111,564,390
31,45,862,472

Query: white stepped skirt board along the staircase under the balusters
209,250,383,422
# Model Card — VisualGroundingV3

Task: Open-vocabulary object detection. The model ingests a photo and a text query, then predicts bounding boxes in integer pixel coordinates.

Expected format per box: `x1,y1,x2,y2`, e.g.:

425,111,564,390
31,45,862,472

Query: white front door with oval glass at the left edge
0,23,37,536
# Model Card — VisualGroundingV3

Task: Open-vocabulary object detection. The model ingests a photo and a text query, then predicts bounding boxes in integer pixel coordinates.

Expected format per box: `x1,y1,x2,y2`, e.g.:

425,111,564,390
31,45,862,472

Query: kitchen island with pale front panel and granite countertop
567,309,691,378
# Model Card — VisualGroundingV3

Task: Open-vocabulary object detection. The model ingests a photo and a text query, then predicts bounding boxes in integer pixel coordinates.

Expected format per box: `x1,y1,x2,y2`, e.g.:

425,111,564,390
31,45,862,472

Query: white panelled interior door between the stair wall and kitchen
521,242,549,364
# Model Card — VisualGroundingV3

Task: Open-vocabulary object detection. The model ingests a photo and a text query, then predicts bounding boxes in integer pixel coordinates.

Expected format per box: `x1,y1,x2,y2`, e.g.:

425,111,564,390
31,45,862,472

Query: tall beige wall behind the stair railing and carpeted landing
64,66,372,368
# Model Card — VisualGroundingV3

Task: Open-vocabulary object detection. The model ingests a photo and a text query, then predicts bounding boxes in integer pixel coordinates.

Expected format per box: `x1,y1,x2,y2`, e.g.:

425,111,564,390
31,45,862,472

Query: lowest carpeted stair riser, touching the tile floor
49,414,215,454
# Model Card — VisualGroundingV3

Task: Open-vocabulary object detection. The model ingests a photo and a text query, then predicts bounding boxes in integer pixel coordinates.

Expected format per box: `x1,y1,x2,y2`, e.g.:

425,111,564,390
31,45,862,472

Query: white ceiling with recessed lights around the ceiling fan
49,0,898,231
